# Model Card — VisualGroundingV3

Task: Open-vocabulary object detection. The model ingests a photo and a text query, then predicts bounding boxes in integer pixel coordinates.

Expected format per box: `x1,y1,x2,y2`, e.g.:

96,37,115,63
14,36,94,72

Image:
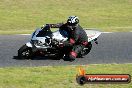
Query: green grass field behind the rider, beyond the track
0,0,132,34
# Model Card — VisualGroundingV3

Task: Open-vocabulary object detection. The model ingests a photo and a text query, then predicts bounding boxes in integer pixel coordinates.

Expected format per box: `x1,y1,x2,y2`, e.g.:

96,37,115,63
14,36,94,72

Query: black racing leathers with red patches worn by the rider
60,23,88,61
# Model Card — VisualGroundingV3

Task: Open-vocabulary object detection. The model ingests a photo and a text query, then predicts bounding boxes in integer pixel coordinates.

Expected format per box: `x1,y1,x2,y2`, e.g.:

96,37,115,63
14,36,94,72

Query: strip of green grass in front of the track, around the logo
0,64,132,88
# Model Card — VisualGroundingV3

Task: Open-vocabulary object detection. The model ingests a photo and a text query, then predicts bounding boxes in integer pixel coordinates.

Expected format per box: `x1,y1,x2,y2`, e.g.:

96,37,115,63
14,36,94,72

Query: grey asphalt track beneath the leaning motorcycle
0,32,132,67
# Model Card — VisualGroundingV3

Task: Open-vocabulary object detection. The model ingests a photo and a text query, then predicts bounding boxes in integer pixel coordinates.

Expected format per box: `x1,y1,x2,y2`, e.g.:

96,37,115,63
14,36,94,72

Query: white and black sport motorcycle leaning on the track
18,24,101,59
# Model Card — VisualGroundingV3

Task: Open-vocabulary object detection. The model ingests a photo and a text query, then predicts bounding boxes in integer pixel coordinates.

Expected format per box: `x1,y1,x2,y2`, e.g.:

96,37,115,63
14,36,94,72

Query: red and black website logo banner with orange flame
76,67,131,85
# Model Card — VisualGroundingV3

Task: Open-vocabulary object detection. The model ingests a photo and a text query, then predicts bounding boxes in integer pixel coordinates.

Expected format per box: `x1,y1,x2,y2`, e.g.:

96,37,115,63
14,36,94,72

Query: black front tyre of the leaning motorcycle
18,45,33,59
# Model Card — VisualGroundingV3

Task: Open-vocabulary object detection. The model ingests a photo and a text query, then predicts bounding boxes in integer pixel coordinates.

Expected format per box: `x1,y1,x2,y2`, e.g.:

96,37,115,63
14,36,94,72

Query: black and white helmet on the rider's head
67,16,79,27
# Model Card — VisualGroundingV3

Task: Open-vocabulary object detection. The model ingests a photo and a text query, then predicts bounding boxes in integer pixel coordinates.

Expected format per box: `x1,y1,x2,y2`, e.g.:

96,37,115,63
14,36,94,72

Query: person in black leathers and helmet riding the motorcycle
41,16,88,61
